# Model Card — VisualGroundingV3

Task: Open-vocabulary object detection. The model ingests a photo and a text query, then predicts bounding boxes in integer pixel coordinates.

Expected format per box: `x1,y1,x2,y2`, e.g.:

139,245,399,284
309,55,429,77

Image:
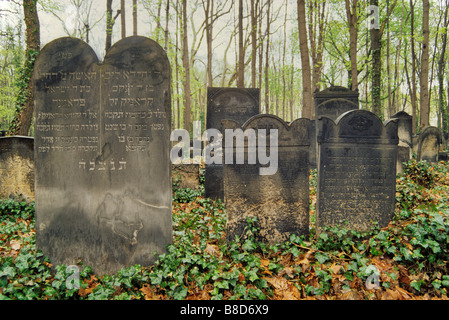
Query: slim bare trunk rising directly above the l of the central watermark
181,0,191,131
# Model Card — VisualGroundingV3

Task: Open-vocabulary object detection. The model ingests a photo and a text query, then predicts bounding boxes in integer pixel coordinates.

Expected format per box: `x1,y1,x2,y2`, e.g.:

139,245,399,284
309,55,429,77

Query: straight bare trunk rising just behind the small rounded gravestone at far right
419,0,430,129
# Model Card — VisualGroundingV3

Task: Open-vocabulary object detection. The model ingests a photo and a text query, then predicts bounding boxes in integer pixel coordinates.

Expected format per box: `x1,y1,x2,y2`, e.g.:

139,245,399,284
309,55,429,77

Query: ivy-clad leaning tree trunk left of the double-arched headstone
9,0,40,136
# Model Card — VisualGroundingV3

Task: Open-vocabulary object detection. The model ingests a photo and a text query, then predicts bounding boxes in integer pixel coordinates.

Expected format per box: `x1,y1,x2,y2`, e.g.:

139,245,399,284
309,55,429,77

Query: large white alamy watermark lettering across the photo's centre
170,121,278,175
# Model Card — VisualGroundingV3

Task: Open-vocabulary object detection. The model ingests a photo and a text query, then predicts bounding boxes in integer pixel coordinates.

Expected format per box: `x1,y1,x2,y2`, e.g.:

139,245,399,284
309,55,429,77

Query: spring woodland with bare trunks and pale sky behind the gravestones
0,0,449,135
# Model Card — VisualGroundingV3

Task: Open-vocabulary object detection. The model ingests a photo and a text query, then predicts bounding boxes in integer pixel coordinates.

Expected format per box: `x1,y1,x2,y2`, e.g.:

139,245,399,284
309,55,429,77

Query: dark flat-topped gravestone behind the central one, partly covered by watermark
204,87,260,200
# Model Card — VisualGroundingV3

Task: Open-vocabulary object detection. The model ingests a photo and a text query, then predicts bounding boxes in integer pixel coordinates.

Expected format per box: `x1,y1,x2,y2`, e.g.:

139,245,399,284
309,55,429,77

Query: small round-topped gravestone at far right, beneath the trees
418,126,443,163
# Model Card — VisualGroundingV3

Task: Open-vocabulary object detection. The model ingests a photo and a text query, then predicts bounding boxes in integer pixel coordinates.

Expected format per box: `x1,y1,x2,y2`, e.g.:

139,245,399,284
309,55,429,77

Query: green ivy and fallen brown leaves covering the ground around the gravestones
0,160,449,300
